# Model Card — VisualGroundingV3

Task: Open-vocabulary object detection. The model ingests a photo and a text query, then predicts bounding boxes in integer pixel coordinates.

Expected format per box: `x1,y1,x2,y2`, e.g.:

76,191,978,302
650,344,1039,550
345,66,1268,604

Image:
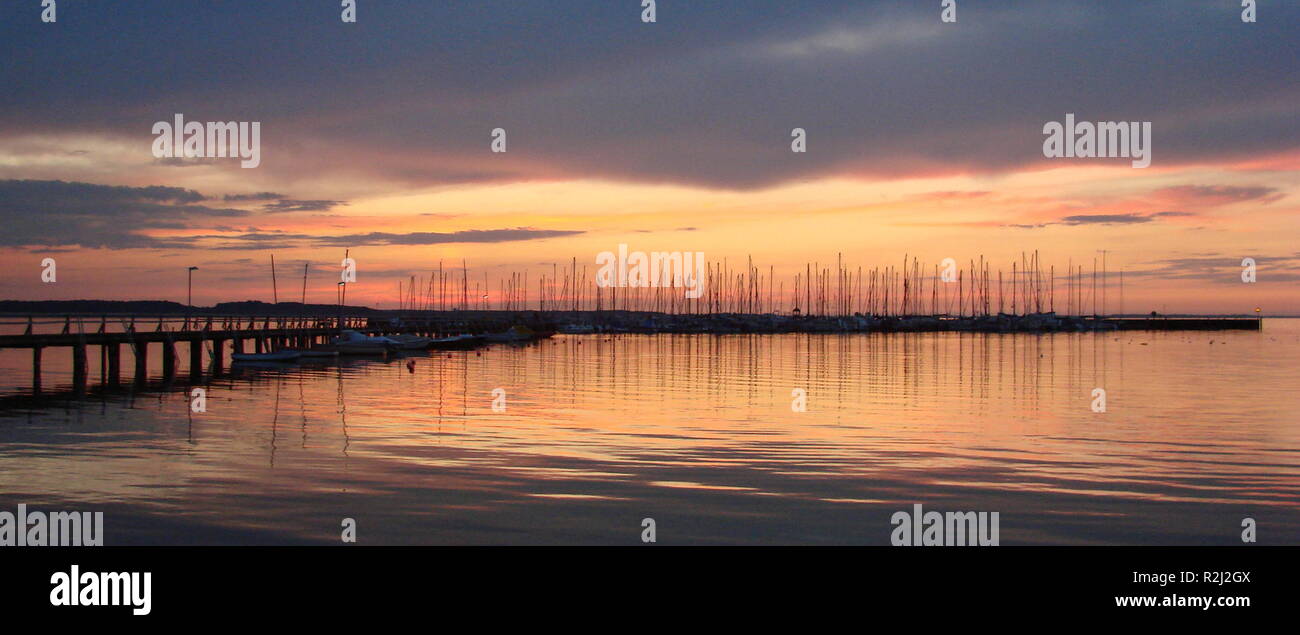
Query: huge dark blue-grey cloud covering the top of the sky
0,0,1300,189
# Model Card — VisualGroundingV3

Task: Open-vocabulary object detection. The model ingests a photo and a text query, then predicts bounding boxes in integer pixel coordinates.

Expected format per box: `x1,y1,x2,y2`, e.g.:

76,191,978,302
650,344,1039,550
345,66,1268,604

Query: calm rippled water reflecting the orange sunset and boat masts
0,320,1300,545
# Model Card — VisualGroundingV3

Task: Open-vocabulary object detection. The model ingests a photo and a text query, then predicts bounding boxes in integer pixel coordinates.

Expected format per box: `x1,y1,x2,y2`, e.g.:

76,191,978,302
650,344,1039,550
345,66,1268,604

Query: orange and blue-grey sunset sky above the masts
0,0,1300,314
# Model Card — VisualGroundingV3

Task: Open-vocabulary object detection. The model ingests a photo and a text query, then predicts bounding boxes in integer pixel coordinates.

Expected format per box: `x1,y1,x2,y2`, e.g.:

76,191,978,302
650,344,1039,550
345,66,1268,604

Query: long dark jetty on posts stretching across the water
0,310,1261,394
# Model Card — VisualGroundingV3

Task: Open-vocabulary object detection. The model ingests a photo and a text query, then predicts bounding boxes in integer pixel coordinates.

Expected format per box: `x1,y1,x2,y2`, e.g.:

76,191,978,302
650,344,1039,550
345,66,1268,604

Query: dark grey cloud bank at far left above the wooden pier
0,181,248,249
